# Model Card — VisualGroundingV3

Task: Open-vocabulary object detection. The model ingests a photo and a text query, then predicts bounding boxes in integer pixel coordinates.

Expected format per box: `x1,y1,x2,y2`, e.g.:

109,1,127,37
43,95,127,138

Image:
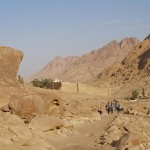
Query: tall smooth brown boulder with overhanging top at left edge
0,46,23,107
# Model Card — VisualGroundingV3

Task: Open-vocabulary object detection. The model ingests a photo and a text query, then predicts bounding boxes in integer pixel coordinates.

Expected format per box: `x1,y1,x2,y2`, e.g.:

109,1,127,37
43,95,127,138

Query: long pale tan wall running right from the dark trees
61,82,111,96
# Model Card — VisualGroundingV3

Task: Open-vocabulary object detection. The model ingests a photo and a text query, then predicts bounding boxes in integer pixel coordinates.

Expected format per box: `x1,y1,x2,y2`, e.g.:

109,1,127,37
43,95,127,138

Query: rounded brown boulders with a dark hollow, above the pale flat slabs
8,93,63,122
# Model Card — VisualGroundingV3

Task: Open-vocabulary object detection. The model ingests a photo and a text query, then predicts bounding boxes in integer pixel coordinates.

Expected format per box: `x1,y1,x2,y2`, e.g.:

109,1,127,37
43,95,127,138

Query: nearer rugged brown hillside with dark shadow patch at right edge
93,36,150,96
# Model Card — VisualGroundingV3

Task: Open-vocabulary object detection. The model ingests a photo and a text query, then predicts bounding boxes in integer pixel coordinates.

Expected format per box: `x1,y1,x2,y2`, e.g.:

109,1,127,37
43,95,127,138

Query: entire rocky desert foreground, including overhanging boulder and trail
0,47,150,150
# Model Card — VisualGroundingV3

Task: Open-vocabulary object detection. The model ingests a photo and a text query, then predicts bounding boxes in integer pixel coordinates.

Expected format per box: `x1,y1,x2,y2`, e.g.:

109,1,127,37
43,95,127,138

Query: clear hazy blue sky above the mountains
0,0,150,77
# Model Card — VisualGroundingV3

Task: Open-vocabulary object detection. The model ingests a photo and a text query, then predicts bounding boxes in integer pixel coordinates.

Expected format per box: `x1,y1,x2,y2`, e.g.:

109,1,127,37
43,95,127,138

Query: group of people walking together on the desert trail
98,100,123,115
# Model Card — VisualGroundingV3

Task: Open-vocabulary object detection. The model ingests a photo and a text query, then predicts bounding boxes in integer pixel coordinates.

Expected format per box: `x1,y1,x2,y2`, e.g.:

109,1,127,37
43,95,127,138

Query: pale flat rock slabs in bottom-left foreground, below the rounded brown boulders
0,109,64,150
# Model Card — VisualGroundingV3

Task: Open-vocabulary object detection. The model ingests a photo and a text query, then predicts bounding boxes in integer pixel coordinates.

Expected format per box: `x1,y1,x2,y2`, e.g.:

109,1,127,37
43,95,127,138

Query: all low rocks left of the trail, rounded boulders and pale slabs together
0,93,100,150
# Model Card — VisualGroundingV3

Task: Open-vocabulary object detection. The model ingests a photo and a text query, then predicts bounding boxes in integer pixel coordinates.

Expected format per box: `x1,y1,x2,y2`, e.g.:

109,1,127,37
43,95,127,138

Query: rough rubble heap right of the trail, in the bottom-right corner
100,114,150,150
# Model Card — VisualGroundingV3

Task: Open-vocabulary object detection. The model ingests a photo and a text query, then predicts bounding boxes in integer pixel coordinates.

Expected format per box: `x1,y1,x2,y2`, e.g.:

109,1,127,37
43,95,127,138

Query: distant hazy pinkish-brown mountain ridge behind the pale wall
31,38,139,83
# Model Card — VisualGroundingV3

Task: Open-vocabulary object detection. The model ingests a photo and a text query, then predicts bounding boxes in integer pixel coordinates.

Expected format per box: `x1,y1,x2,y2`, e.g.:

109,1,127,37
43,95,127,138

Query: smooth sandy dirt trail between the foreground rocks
52,114,115,150
